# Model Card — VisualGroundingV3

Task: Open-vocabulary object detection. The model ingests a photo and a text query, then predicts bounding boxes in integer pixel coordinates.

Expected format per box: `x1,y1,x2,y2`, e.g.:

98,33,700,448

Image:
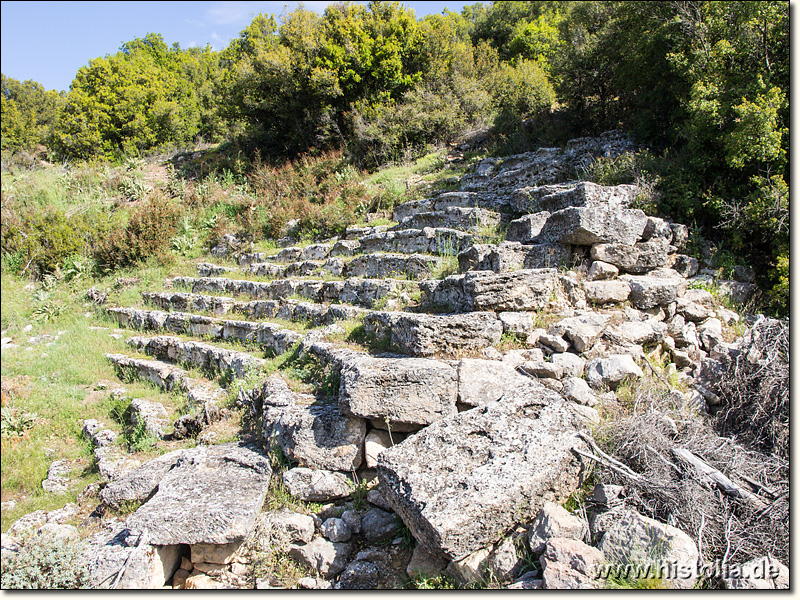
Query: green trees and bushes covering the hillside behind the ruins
2,1,789,312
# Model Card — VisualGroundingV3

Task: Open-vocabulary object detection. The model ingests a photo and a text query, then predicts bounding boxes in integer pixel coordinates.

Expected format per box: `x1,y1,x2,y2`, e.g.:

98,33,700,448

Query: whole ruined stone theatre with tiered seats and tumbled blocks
3,135,788,589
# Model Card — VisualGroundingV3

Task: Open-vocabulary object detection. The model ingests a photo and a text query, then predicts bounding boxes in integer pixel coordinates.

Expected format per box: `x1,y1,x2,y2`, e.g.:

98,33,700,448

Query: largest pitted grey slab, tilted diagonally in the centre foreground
378,386,584,559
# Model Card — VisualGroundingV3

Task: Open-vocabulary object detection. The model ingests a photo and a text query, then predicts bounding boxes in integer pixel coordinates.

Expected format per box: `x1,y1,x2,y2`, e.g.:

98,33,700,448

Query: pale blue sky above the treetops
0,0,475,90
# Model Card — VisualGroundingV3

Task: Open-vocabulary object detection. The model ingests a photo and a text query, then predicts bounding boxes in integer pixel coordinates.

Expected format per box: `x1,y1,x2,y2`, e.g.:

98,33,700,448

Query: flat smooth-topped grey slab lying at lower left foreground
127,442,272,545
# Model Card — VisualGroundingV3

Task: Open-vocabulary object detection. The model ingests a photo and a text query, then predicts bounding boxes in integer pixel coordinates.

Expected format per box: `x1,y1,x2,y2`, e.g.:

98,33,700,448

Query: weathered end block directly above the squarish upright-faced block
364,312,503,356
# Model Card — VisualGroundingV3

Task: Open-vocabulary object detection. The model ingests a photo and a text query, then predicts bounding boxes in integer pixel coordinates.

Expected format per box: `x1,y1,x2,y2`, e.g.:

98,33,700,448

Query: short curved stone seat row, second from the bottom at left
127,335,266,378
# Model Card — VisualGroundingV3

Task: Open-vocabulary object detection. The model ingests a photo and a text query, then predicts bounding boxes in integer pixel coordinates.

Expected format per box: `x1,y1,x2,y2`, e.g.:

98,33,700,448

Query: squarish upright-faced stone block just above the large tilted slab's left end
339,355,458,425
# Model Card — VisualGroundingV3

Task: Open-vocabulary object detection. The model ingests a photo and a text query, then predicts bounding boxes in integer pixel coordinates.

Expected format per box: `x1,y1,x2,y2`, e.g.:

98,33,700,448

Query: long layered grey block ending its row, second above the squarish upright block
419,269,561,313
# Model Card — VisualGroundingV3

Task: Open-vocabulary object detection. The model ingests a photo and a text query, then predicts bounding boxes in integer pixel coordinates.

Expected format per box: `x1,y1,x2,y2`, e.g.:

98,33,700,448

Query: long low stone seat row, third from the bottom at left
106,308,303,354
